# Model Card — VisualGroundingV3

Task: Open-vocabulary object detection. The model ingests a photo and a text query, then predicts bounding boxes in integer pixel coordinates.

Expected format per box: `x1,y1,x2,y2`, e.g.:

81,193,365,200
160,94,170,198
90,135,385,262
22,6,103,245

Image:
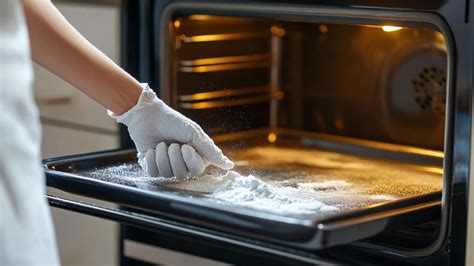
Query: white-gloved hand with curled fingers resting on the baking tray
108,84,234,179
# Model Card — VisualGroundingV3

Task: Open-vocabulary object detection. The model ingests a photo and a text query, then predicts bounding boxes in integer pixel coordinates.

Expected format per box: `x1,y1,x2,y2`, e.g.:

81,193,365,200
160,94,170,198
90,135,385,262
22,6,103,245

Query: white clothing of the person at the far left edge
0,0,59,266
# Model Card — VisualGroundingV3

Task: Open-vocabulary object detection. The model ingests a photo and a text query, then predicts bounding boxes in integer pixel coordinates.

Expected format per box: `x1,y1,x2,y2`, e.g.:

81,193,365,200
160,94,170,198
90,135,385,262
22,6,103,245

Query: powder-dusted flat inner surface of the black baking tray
75,143,443,219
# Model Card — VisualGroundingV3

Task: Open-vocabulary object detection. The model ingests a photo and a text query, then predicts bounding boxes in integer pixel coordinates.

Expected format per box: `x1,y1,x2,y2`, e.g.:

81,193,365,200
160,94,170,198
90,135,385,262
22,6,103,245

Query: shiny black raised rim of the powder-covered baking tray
43,149,442,249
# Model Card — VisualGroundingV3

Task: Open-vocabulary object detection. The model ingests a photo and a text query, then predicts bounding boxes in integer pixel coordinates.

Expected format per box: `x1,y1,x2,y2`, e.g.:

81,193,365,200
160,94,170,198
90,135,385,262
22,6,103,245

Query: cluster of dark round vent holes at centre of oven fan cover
412,66,446,116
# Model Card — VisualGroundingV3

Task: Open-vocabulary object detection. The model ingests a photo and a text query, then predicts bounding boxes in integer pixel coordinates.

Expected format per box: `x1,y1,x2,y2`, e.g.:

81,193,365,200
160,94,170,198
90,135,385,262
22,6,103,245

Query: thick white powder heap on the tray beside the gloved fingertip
210,171,338,214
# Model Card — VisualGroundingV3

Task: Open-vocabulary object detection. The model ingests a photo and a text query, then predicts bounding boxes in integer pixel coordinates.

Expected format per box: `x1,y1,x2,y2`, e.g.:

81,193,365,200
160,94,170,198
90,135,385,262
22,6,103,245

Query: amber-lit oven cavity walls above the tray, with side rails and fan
169,15,447,151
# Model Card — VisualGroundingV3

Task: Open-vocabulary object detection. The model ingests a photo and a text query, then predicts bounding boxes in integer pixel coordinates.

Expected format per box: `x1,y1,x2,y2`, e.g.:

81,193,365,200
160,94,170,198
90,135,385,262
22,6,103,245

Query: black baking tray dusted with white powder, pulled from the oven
44,132,443,250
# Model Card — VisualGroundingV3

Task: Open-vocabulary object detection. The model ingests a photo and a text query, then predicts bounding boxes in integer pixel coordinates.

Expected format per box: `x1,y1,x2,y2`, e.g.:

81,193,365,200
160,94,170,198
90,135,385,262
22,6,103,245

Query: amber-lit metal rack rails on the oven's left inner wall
172,22,285,119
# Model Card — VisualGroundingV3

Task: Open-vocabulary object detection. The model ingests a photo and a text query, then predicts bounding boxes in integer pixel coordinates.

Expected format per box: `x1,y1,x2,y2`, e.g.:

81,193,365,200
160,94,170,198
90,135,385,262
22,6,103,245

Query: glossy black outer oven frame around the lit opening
114,0,474,265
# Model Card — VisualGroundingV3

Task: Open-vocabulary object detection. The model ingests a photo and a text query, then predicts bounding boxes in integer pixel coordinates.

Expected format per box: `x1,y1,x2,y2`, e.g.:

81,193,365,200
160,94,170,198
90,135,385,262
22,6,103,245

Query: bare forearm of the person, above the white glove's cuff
23,0,141,114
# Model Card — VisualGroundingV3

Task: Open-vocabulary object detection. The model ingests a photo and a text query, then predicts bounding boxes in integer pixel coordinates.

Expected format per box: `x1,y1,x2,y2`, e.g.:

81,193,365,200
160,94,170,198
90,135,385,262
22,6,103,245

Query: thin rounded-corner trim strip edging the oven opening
160,2,456,257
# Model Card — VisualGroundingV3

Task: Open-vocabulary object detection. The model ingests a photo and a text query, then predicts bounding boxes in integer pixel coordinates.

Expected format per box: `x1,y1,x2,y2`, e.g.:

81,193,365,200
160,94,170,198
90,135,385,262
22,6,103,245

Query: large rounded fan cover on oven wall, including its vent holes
380,36,447,149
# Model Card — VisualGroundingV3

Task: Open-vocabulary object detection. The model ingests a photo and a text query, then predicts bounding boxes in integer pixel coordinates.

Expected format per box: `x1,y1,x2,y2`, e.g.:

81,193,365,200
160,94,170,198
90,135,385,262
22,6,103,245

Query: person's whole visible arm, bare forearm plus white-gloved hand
23,0,233,178
